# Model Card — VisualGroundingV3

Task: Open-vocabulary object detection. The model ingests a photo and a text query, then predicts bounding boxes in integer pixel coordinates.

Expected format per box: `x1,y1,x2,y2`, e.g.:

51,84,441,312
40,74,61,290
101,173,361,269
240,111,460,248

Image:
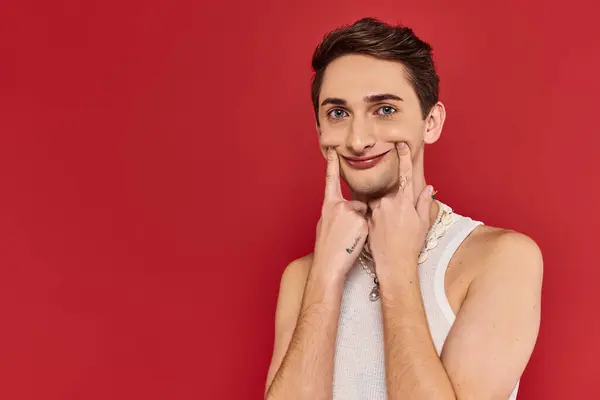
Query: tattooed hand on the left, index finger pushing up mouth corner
312,148,369,280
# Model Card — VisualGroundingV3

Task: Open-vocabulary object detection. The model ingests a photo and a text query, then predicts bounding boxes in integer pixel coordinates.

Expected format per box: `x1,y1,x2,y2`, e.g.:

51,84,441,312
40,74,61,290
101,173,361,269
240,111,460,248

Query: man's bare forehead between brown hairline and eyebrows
319,54,417,102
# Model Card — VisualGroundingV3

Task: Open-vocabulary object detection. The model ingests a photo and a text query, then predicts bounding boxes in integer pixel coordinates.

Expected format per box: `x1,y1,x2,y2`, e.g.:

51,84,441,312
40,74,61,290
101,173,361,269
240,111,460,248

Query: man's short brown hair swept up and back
311,18,439,123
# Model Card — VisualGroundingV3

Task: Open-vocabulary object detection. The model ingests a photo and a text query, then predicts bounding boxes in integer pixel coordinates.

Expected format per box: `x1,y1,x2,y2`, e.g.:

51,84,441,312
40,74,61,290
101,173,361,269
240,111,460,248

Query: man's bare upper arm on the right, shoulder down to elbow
442,232,543,400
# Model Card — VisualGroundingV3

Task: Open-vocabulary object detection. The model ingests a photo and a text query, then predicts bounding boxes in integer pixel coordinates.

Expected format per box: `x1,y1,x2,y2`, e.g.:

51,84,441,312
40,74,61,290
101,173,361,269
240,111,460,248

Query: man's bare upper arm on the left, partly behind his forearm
265,256,311,391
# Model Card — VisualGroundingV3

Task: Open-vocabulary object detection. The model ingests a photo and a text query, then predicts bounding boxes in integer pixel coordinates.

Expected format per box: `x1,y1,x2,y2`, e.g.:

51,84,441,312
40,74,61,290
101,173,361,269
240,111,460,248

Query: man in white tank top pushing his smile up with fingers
265,19,543,400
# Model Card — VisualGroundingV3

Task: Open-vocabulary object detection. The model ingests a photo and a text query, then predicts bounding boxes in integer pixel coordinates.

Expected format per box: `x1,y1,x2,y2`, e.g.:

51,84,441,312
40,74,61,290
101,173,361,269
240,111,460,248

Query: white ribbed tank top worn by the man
333,200,519,400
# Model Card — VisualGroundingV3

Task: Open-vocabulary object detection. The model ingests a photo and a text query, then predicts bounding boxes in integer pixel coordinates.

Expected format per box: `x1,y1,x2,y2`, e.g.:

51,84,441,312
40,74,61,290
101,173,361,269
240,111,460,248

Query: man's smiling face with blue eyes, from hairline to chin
318,55,426,197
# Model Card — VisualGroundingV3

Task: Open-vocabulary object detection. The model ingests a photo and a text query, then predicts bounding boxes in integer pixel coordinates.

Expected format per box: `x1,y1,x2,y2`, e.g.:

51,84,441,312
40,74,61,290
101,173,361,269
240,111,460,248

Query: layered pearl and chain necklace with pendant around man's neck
358,200,453,301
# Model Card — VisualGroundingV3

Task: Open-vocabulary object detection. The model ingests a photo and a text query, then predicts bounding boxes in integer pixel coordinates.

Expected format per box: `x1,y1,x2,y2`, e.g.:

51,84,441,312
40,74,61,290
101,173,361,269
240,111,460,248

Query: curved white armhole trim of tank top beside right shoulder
433,220,483,325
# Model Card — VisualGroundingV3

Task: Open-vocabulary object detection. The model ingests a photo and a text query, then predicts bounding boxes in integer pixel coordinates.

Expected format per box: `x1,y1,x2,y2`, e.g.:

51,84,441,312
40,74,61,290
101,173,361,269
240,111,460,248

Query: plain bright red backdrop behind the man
0,0,600,400
